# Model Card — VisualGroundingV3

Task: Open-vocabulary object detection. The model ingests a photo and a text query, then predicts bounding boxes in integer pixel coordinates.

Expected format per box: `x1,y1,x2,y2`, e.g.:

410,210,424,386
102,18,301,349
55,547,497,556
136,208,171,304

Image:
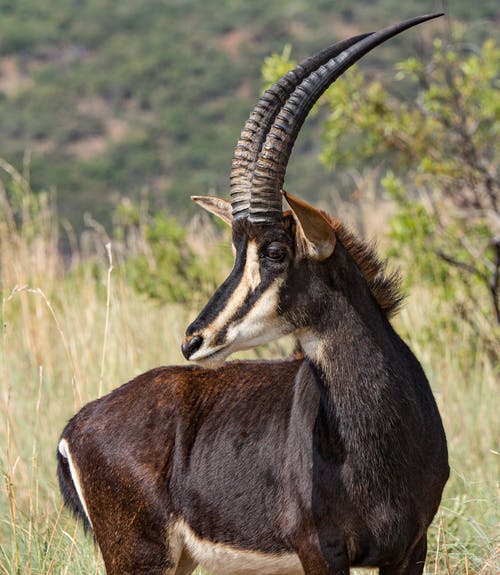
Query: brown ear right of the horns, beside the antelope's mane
283,191,337,260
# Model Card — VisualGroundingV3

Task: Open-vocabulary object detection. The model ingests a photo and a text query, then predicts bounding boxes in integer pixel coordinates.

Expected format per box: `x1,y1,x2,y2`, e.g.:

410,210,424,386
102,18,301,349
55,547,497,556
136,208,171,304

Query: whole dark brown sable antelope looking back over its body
58,15,449,575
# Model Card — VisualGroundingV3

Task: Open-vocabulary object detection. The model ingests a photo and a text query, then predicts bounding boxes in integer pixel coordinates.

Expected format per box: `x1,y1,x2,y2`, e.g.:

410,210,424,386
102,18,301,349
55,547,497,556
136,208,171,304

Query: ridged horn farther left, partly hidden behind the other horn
230,34,370,218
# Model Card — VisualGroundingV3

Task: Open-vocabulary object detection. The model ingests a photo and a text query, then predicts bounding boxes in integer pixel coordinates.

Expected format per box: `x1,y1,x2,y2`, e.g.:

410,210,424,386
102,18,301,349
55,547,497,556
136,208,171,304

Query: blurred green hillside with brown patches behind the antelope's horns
0,0,499,228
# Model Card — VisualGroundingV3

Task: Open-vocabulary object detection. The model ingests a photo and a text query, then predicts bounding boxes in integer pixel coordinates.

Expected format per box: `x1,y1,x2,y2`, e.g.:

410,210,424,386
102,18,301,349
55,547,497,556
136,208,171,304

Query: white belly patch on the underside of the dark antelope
172,521,304,575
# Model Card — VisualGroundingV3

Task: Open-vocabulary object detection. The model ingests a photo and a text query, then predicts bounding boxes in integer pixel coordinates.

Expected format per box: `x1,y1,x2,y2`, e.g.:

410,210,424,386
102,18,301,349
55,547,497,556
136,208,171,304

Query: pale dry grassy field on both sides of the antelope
0,174,500,575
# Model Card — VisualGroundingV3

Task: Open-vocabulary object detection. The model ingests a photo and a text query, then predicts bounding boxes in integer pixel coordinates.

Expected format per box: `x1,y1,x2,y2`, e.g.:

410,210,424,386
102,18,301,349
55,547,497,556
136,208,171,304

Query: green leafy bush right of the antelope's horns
316,33,500,338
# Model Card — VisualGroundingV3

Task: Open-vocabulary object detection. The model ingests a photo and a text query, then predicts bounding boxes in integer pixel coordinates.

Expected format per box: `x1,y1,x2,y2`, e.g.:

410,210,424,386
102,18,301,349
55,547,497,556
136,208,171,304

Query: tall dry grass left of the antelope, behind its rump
0,164,199,574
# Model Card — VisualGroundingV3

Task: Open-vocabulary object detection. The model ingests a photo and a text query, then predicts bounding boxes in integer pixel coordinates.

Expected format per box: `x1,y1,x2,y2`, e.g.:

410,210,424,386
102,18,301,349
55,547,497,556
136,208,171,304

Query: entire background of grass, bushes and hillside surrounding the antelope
0,0,500,575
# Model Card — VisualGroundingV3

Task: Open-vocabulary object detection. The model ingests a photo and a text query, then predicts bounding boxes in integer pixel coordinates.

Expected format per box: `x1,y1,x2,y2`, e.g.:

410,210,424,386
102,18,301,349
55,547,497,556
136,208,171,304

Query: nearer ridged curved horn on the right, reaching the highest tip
248,13,443,223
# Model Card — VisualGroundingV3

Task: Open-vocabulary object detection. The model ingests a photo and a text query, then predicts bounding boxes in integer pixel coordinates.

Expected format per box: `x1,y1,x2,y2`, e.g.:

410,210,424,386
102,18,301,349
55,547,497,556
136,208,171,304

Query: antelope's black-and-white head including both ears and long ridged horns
182,14,440,366
